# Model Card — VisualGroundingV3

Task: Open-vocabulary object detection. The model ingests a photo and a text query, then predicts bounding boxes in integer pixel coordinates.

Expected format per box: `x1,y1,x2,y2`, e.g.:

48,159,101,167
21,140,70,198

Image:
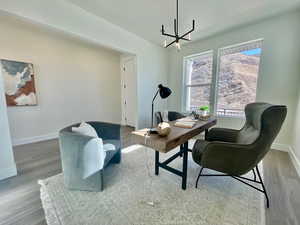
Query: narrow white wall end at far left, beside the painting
0,66,17,180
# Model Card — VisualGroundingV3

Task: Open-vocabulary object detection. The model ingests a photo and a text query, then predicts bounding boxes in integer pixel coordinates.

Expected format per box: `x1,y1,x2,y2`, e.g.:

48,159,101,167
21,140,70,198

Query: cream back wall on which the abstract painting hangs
0,16,121,144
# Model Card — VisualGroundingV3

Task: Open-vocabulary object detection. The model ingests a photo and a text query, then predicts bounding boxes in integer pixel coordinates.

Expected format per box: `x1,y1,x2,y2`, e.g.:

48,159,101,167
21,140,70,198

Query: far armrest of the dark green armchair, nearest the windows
206,128,239,143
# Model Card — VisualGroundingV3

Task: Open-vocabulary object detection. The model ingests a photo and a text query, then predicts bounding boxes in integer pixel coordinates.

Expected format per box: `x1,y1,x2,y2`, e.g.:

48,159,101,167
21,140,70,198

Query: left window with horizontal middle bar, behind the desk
184,51,213,111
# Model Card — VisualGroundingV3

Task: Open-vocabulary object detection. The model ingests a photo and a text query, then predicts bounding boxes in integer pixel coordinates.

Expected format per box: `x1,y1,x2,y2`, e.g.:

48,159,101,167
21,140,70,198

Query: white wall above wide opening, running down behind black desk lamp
0,0,168,128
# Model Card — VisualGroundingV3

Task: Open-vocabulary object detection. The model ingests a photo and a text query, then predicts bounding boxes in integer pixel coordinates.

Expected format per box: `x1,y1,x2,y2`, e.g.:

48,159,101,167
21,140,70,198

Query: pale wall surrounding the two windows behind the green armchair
168,9,300,150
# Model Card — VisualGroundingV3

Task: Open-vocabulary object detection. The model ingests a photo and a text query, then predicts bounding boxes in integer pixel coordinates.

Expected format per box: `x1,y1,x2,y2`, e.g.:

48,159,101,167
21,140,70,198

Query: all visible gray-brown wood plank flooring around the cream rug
0,128,300,225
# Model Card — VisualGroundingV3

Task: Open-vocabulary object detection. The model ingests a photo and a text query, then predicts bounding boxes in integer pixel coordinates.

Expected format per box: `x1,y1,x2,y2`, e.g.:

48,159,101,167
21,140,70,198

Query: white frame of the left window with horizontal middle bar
181,49,214,113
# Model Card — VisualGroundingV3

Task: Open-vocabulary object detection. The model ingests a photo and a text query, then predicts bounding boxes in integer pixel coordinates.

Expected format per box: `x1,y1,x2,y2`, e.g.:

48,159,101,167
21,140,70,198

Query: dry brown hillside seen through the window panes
191,53,260,113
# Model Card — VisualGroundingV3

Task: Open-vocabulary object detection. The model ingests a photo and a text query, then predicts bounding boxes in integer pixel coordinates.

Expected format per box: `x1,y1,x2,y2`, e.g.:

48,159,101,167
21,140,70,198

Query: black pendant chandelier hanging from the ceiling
161,0,195,50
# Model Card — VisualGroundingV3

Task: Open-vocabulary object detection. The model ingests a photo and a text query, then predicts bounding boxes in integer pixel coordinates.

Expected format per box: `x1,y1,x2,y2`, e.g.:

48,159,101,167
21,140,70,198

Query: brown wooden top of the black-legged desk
132,118,217,153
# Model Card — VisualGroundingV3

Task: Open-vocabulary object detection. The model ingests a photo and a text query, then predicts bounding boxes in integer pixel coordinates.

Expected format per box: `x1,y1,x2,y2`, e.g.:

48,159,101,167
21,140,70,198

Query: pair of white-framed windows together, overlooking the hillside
183,39,263,117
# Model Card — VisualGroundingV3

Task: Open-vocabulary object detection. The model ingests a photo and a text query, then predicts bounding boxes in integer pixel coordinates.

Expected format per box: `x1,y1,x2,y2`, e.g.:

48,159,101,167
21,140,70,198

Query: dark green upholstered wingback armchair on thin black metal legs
193,103,287,207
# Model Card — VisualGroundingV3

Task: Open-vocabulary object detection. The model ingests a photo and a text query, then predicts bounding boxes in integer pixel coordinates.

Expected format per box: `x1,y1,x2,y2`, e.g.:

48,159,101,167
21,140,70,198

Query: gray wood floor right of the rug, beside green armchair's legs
264,151,300,225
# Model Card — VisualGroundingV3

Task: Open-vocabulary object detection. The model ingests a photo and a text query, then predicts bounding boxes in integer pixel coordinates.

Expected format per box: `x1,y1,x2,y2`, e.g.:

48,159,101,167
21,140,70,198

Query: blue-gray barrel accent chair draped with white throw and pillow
59,122,121,191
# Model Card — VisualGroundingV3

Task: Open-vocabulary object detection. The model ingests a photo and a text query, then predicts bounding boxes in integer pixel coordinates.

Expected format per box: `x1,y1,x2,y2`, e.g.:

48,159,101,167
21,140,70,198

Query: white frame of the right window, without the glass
212,38,264,119
